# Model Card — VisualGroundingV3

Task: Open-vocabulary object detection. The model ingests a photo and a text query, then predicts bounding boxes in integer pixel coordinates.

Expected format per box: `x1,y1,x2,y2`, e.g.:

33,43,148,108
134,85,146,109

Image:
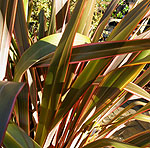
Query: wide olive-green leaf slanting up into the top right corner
108,0,150,41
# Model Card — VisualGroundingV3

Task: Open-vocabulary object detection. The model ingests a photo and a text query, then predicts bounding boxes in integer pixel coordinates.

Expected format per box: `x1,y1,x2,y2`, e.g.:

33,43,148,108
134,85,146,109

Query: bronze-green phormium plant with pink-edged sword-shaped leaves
0,0,150,148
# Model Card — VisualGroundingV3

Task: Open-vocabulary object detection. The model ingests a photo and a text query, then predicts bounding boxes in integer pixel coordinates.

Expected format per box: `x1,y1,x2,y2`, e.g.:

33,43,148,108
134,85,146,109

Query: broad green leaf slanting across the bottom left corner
3,123,41,148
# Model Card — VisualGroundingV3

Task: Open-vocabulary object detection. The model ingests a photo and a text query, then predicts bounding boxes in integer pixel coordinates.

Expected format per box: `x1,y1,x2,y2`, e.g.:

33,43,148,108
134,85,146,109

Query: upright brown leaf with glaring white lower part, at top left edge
0,0,18,80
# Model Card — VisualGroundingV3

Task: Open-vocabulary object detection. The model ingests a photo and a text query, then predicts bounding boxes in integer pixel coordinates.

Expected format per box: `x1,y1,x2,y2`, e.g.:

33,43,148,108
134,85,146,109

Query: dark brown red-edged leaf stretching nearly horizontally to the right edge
70,39,150,65
